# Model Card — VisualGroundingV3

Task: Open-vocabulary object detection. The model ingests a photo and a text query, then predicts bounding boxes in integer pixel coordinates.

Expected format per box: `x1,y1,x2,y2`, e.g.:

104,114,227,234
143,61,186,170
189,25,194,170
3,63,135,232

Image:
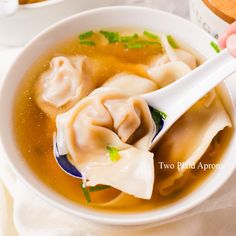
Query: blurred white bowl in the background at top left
0,0,121,46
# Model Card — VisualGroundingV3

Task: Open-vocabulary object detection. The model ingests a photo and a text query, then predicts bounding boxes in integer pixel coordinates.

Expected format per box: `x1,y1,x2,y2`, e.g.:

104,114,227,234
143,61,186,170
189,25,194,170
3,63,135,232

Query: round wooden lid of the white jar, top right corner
203,0,236,23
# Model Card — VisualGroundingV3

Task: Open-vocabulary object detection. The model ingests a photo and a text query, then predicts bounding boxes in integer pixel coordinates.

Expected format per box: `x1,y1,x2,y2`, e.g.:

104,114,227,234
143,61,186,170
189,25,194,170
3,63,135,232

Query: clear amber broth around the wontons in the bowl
13,30,231,212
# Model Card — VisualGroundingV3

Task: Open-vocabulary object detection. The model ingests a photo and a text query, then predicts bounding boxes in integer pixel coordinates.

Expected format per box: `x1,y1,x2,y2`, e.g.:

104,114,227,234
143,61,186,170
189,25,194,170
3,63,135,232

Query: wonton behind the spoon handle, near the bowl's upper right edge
147,36,197,87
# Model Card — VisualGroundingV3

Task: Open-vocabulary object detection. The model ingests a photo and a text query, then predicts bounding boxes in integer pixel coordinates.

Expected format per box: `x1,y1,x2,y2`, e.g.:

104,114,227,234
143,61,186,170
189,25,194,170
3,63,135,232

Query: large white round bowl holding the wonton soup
0,7,236,225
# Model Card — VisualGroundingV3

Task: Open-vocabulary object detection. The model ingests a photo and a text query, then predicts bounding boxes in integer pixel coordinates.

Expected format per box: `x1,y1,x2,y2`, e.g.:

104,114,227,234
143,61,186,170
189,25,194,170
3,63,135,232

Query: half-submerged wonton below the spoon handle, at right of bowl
155,94,231,195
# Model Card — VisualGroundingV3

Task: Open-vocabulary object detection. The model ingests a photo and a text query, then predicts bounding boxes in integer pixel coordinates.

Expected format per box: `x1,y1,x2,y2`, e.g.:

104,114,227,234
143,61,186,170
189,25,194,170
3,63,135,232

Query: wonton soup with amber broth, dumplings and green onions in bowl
14,30,232,212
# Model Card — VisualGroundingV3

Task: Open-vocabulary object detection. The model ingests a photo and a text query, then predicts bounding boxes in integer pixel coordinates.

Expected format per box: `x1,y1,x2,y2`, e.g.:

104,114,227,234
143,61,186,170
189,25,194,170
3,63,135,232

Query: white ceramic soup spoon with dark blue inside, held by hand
54,49,236,178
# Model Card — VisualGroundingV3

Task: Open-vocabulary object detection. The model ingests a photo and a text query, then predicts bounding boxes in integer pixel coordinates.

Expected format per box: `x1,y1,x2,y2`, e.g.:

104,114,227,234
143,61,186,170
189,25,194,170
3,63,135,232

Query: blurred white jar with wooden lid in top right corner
190,0,236,38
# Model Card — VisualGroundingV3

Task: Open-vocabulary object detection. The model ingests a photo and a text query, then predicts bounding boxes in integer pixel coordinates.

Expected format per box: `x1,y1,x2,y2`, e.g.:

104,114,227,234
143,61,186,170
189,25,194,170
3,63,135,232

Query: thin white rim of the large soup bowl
0,6,236,226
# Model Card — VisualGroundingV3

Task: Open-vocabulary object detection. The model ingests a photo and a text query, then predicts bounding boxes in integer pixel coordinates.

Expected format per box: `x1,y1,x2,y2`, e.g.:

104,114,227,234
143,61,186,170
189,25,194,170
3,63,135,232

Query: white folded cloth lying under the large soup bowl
0,49,236,236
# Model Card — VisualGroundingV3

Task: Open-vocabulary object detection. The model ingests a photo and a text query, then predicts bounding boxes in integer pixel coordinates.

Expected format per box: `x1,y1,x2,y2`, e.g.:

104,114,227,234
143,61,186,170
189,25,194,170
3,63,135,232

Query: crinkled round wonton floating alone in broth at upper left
35,56,93,117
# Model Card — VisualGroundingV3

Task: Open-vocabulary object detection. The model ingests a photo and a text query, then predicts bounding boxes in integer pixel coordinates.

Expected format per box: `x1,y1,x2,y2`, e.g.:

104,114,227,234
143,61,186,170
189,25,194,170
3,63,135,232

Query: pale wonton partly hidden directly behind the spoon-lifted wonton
102,73,158,96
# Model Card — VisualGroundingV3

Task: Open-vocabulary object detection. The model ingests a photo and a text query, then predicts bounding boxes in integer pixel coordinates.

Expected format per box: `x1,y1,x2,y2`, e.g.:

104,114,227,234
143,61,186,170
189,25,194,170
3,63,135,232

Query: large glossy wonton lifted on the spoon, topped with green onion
56,88,155,199
